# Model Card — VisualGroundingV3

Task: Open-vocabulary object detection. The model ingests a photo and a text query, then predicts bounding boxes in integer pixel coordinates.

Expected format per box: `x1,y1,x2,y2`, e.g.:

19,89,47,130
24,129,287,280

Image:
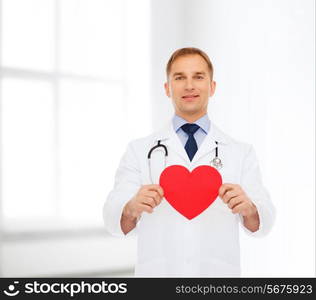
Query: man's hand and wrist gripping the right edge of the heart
218,183,260,232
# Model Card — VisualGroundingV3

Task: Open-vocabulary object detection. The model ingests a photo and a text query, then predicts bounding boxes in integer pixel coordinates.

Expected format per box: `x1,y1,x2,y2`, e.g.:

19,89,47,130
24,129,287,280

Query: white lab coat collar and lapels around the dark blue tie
154,120,230,164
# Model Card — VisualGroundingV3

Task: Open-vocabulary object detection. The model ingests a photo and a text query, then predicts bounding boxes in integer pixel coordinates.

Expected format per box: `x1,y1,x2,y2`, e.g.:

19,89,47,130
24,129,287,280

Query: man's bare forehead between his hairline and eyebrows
170,54,208,74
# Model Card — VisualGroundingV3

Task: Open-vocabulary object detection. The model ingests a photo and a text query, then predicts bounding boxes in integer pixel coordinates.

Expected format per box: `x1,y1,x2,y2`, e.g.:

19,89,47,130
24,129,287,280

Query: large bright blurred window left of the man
0,0,151,229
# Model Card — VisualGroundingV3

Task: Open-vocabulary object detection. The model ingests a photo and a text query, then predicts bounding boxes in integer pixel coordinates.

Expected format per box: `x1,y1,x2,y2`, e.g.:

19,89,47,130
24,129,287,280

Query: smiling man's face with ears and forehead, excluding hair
165,54,216,119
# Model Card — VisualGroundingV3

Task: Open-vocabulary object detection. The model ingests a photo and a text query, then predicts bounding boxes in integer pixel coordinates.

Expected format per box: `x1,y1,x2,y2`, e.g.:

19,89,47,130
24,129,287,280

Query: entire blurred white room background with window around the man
0,0,315,277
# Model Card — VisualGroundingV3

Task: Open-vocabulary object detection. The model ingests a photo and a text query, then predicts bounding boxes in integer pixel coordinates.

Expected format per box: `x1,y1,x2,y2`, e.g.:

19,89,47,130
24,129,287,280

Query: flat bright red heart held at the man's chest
159,165,222,220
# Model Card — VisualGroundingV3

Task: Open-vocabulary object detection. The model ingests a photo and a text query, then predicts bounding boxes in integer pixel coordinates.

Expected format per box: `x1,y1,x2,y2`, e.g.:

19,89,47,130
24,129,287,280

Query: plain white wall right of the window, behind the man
151,0,315,277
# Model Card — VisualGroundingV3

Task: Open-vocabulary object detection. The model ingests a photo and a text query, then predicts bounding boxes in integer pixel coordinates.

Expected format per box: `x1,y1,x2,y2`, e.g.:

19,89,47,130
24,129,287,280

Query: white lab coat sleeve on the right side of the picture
239,146,275,237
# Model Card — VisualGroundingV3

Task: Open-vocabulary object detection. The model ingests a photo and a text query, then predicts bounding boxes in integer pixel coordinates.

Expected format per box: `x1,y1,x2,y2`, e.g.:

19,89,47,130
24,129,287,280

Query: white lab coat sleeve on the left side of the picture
103,142,141,237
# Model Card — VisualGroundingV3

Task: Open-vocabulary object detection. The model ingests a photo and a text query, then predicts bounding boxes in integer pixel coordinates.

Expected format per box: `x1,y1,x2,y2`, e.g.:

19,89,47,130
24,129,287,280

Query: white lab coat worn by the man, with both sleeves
103,121,275,277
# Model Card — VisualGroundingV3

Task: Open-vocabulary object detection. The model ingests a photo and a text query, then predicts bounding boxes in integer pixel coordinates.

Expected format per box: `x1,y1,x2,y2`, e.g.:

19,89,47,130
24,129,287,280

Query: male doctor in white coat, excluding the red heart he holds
103,48,274,277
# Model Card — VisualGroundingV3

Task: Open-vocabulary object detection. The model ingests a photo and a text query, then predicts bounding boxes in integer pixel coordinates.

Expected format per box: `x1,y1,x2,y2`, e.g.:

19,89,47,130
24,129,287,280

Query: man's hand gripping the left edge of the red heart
123,184,163,219
